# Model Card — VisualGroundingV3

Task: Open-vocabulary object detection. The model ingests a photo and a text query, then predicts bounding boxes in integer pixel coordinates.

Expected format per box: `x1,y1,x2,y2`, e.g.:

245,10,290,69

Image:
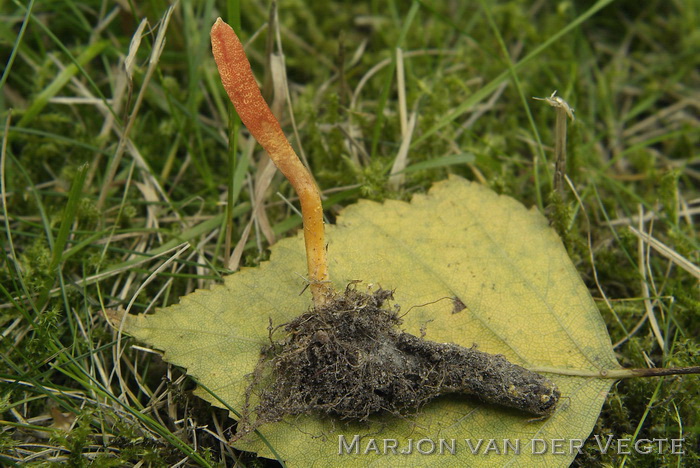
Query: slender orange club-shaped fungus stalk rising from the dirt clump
211,18,332,307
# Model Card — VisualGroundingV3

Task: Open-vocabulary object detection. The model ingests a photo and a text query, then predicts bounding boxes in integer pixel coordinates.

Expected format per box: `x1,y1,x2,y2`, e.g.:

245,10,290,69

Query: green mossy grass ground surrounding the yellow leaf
0,0,700,466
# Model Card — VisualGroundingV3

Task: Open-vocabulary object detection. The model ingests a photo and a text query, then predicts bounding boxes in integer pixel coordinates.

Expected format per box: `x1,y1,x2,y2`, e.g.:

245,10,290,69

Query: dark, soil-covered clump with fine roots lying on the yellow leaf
239,285,559,435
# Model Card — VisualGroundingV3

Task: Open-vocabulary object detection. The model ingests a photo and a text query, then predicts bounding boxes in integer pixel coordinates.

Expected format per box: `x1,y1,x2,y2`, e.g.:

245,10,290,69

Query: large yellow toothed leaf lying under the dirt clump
125,177,619,466
